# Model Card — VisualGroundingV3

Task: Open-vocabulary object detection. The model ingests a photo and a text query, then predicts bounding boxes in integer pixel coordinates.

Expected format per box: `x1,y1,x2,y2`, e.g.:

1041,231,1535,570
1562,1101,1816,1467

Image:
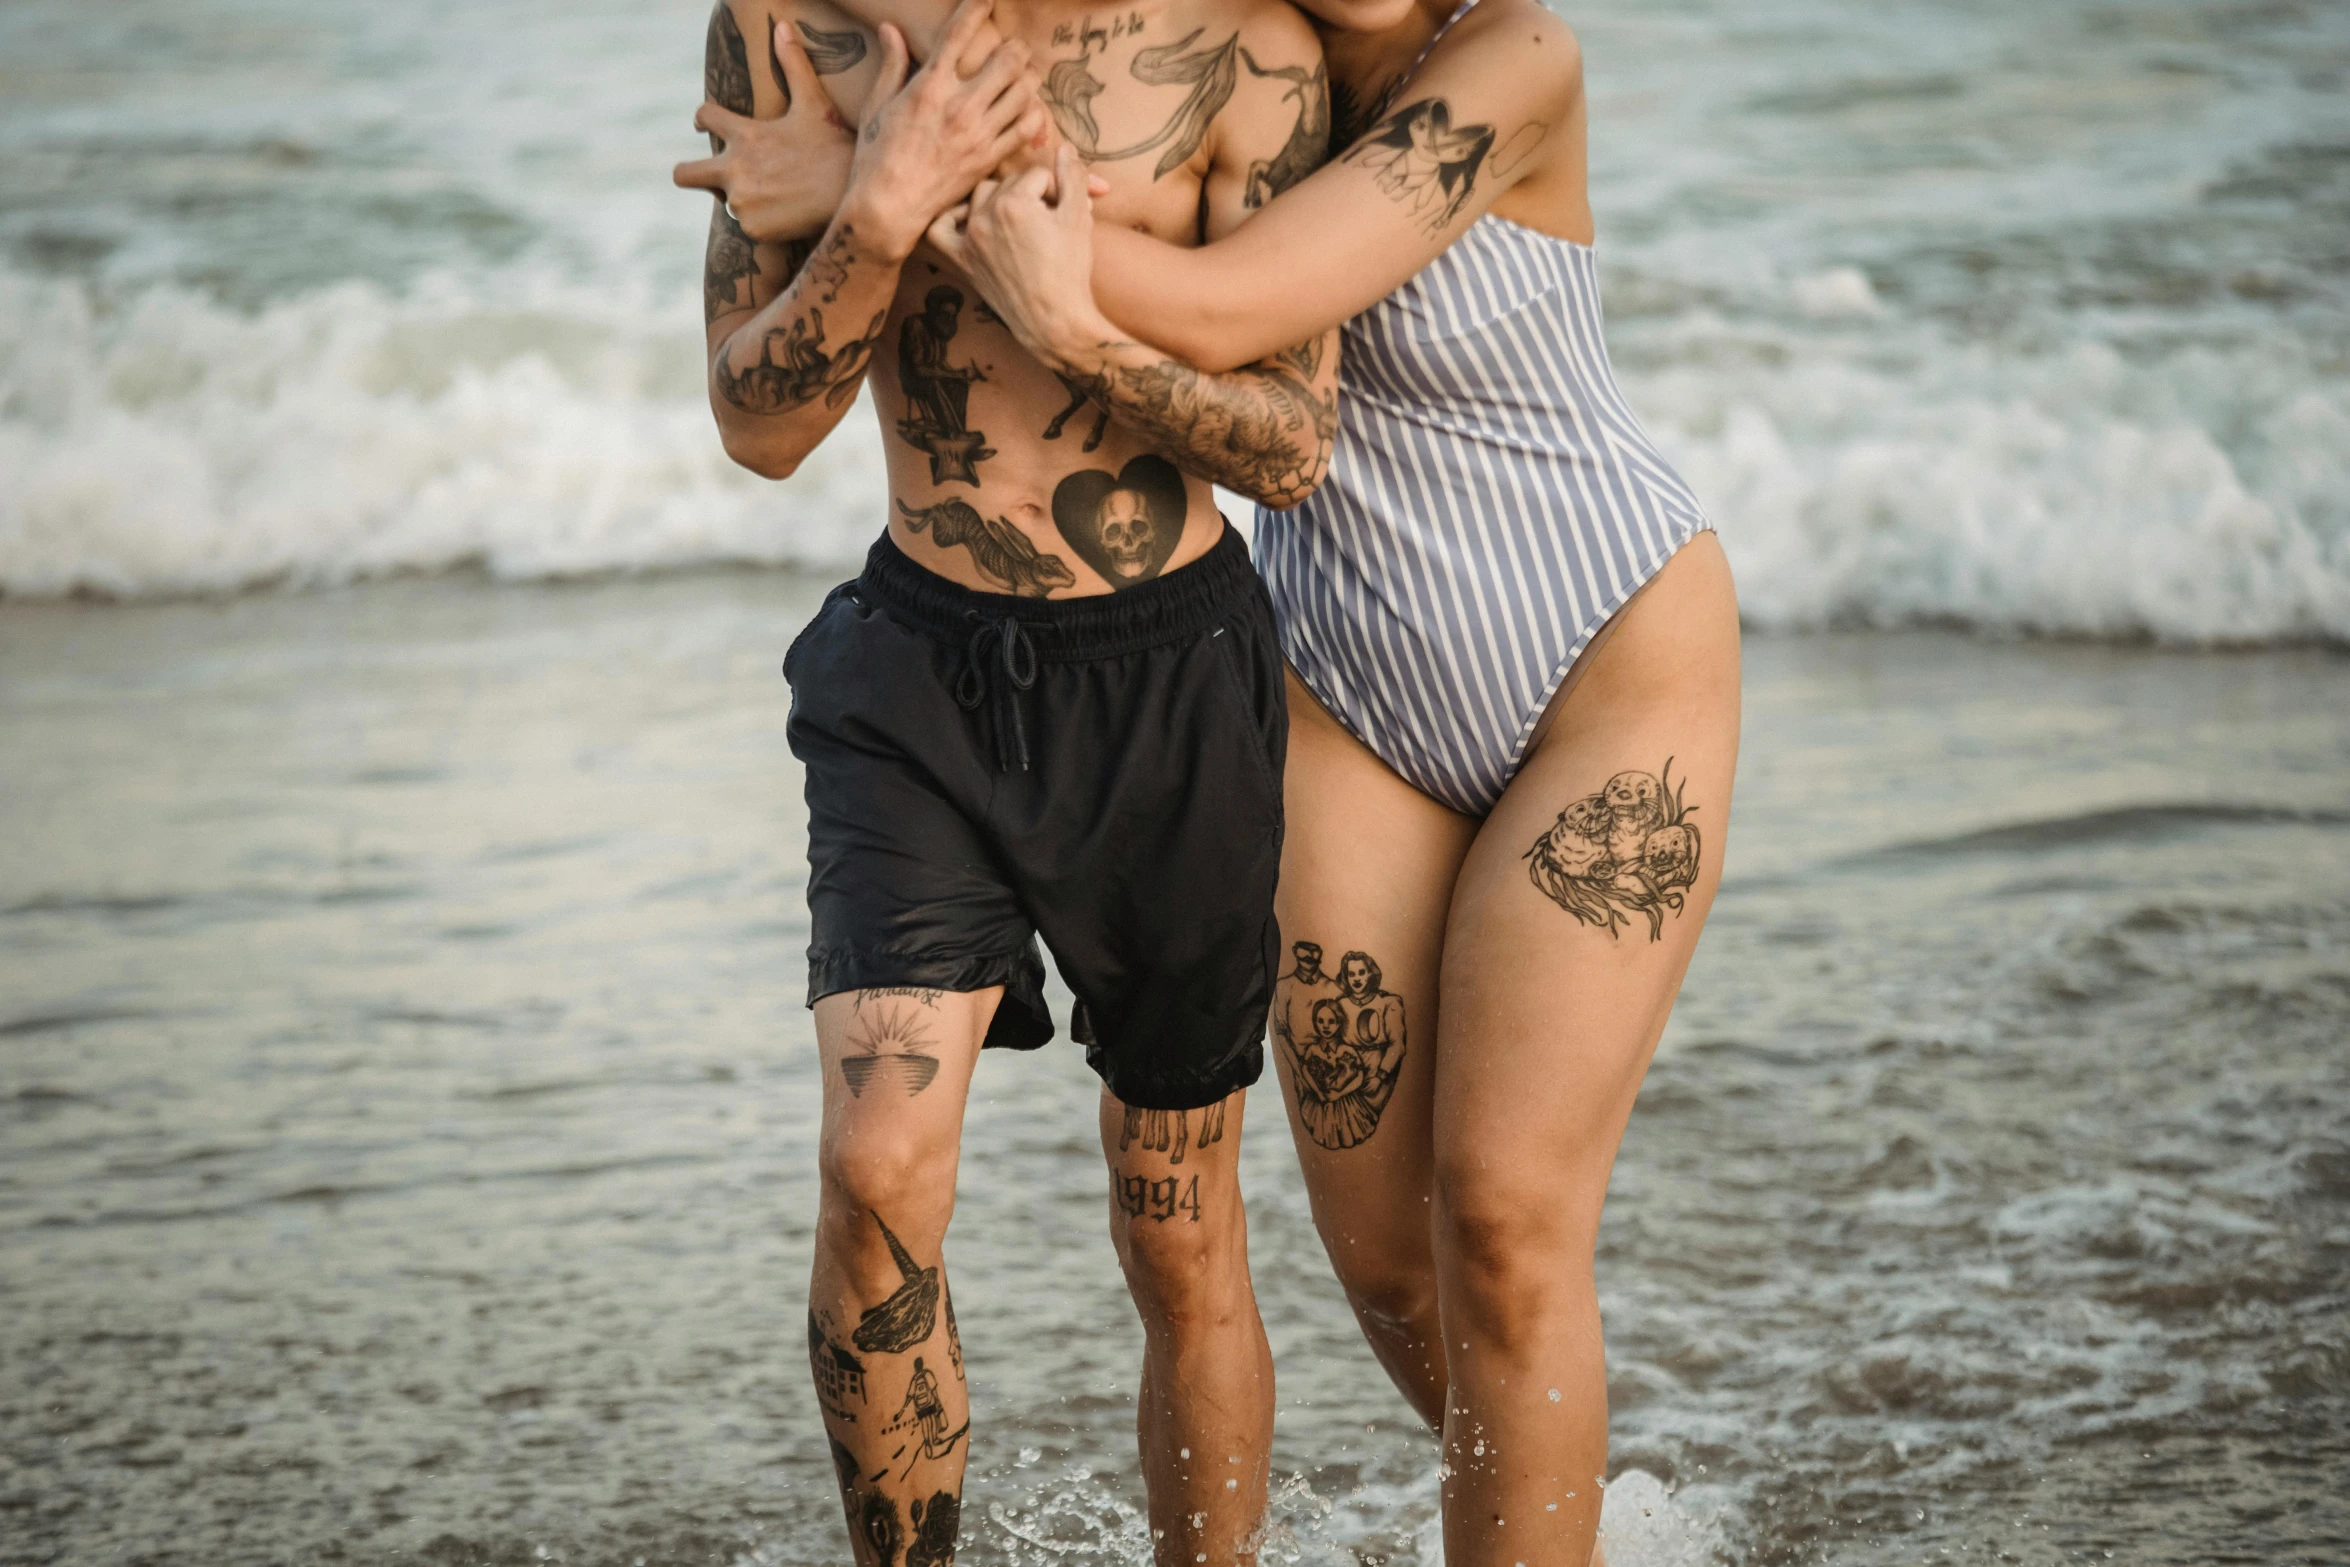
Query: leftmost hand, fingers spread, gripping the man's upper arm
670,21,858,244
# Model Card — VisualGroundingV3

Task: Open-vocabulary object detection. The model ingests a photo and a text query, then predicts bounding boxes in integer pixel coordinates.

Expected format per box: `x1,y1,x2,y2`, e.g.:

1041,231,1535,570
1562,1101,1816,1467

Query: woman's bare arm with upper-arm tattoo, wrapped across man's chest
1093,0,1582,371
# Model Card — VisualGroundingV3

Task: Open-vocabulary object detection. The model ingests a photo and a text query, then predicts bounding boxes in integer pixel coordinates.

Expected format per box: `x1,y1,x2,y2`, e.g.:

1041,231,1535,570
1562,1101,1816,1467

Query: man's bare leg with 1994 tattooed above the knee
1102,1088,1274,1567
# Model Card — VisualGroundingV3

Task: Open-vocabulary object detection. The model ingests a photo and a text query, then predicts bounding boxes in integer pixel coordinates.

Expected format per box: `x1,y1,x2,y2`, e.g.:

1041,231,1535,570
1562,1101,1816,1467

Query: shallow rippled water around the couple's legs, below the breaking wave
0,576,2350,1567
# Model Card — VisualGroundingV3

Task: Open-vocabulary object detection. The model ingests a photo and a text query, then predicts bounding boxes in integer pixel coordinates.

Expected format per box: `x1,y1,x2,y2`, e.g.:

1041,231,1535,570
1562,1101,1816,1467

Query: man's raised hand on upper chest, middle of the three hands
839,0,1050,261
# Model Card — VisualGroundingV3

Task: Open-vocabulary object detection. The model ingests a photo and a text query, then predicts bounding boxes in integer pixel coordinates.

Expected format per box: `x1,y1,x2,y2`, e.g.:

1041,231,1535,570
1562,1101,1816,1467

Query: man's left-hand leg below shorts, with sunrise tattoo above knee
808,987,1003,1567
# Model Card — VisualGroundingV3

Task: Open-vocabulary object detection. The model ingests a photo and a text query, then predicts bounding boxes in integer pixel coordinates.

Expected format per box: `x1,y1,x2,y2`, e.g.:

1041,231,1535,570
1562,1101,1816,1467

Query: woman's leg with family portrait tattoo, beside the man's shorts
1271,674,1476,1428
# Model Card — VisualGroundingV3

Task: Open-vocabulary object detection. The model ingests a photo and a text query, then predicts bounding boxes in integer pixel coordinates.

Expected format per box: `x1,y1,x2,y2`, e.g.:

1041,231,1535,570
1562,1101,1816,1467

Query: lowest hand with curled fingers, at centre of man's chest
931,141,1121,366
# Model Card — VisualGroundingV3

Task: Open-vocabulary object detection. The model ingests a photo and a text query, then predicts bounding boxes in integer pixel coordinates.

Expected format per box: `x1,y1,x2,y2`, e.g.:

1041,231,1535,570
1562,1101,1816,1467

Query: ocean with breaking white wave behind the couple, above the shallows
0,0,2350,641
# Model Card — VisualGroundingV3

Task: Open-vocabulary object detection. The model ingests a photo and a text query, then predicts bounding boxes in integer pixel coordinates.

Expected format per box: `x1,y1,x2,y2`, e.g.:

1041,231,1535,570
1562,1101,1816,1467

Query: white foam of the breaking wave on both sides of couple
0,273,2350,641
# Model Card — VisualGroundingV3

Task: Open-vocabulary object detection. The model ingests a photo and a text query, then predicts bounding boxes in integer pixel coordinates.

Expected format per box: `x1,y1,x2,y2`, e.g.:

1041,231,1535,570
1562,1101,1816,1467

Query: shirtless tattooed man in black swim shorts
679,0,1337,1567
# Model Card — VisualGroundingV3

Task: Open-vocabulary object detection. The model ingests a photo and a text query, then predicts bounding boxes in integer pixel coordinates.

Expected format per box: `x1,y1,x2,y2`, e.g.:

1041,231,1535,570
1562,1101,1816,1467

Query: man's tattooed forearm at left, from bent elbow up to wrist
710,216,905,479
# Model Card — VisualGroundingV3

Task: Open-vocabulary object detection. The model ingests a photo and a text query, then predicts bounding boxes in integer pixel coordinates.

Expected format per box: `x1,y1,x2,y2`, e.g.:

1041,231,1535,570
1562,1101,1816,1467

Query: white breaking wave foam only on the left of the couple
0,275,884,597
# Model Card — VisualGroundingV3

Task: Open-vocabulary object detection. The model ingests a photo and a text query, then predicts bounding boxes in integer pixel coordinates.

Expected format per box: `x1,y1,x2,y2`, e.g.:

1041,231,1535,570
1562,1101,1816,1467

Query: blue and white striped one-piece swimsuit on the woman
1255,217,1708,815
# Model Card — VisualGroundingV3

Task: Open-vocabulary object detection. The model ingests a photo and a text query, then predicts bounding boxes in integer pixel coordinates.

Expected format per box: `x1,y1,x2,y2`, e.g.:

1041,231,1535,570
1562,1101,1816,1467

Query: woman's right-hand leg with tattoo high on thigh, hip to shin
1434,533,1739,1567
